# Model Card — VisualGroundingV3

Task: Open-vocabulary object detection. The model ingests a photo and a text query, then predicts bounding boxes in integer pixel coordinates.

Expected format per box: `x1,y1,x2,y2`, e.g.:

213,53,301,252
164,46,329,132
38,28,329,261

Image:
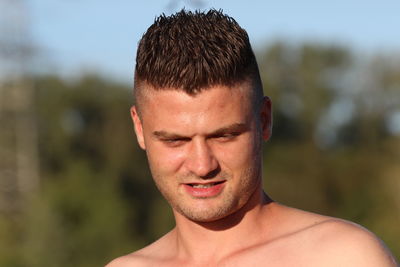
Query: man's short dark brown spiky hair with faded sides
134,9,263,104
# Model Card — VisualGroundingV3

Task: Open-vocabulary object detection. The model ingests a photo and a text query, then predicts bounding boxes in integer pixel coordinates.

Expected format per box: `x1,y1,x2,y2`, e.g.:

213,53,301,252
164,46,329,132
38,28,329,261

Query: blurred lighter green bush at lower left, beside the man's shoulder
23,162,135,266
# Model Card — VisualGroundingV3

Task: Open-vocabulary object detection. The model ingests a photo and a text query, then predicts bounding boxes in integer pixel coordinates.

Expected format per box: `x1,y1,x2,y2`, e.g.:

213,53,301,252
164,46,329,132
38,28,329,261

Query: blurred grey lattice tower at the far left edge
0,0,39,212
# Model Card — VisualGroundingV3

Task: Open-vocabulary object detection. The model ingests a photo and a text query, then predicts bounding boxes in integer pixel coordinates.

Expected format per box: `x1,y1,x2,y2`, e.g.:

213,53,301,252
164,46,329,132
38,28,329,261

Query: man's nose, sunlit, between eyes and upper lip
186,140,218,179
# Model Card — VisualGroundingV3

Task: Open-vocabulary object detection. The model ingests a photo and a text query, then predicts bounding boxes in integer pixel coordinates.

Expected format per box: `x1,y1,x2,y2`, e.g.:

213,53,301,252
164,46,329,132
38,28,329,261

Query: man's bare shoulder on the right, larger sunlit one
268,203,398,266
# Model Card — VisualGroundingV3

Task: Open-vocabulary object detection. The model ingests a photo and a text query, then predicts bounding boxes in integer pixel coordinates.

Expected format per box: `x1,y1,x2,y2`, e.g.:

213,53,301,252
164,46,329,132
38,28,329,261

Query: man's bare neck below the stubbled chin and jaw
170,188,272,261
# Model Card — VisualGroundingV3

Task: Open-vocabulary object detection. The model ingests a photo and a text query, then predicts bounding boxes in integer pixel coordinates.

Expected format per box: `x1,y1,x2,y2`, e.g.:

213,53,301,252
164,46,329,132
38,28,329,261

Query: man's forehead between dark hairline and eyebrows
140,84,252,130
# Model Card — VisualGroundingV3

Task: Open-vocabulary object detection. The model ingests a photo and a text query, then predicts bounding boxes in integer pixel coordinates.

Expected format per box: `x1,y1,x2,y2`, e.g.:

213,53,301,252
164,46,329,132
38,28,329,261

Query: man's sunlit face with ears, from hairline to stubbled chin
132,83,271,222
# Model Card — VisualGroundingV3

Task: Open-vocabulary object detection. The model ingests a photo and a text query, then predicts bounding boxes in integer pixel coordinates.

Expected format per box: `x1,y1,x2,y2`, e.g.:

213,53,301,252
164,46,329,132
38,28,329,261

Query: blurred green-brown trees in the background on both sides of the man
0,43,400,267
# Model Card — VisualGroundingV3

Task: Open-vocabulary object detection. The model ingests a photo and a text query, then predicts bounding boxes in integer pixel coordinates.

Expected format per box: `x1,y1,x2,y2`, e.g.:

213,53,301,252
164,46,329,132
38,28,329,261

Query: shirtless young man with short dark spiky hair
107,10,396,267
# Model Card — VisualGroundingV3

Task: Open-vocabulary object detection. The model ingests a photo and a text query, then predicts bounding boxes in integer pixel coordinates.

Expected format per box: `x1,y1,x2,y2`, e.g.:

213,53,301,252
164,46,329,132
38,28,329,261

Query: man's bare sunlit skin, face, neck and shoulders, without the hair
107,83,397,267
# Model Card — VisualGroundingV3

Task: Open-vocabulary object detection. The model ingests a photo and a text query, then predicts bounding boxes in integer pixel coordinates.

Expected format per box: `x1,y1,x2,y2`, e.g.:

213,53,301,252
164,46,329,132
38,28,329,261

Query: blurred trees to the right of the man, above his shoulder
259,42,400,260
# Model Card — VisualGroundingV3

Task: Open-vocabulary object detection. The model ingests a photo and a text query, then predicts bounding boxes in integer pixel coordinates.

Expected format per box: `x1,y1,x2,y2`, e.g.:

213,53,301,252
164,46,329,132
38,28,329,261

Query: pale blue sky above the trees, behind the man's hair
26,0,400,82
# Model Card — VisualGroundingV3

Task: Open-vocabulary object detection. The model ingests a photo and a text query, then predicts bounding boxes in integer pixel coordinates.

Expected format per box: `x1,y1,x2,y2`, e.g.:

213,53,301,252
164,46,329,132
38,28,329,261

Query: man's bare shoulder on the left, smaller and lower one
106,232,177,267
